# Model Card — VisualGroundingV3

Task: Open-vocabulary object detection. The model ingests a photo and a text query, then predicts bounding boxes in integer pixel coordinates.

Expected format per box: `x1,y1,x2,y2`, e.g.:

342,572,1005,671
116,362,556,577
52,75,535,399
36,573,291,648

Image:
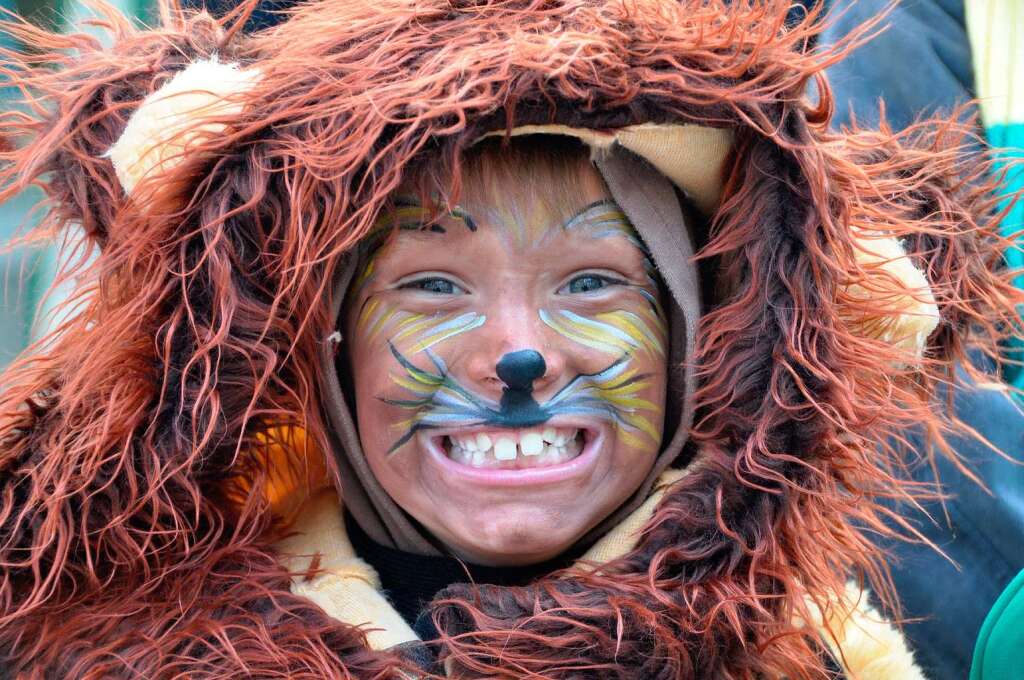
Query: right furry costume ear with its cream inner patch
834,118,1020,365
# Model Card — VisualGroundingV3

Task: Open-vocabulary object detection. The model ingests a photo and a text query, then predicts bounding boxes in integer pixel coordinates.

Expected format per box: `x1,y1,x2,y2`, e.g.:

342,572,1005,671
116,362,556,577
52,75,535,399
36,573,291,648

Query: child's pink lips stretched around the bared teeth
417,422,604,486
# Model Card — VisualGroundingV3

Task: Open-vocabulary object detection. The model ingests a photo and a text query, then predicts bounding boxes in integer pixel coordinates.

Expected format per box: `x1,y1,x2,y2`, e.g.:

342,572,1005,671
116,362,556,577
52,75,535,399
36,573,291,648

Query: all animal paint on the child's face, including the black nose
356,193,666,453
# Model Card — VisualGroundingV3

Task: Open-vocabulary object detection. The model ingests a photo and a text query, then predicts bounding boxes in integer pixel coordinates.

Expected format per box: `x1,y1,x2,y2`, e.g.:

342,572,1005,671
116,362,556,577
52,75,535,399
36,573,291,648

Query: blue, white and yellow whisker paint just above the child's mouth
384,345,660,453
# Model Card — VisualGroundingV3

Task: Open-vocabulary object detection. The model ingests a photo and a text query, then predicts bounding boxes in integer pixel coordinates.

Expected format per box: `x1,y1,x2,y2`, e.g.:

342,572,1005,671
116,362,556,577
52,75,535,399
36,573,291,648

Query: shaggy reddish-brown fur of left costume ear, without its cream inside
0,8,238,245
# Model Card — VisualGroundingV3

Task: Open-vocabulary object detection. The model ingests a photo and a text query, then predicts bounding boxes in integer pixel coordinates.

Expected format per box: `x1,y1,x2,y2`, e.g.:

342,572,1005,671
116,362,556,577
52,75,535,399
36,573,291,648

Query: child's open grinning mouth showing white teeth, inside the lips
433,425,596,470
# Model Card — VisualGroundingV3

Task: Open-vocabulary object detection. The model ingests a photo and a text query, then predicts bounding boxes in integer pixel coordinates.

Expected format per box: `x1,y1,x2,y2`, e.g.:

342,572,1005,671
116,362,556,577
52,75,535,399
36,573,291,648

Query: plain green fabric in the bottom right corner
971,570,1024,680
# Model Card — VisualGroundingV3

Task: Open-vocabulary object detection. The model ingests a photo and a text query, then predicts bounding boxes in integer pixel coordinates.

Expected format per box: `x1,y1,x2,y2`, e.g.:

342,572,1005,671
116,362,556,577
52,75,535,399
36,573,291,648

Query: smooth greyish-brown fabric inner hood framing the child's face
321,142,700,554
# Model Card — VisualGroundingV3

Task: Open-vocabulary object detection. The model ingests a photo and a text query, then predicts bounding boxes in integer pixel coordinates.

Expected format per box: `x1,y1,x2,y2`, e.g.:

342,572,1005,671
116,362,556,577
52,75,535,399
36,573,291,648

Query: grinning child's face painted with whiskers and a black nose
347,157,667,564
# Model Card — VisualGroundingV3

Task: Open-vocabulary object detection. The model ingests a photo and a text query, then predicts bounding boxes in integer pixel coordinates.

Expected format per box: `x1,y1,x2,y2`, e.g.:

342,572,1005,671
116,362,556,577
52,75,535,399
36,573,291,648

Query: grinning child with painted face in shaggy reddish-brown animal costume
0,0,1019,678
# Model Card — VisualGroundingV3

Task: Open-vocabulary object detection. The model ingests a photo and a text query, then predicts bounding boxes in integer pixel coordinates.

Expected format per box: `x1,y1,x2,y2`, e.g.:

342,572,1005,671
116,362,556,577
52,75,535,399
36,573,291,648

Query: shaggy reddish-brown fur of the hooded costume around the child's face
0,0,1021,678
